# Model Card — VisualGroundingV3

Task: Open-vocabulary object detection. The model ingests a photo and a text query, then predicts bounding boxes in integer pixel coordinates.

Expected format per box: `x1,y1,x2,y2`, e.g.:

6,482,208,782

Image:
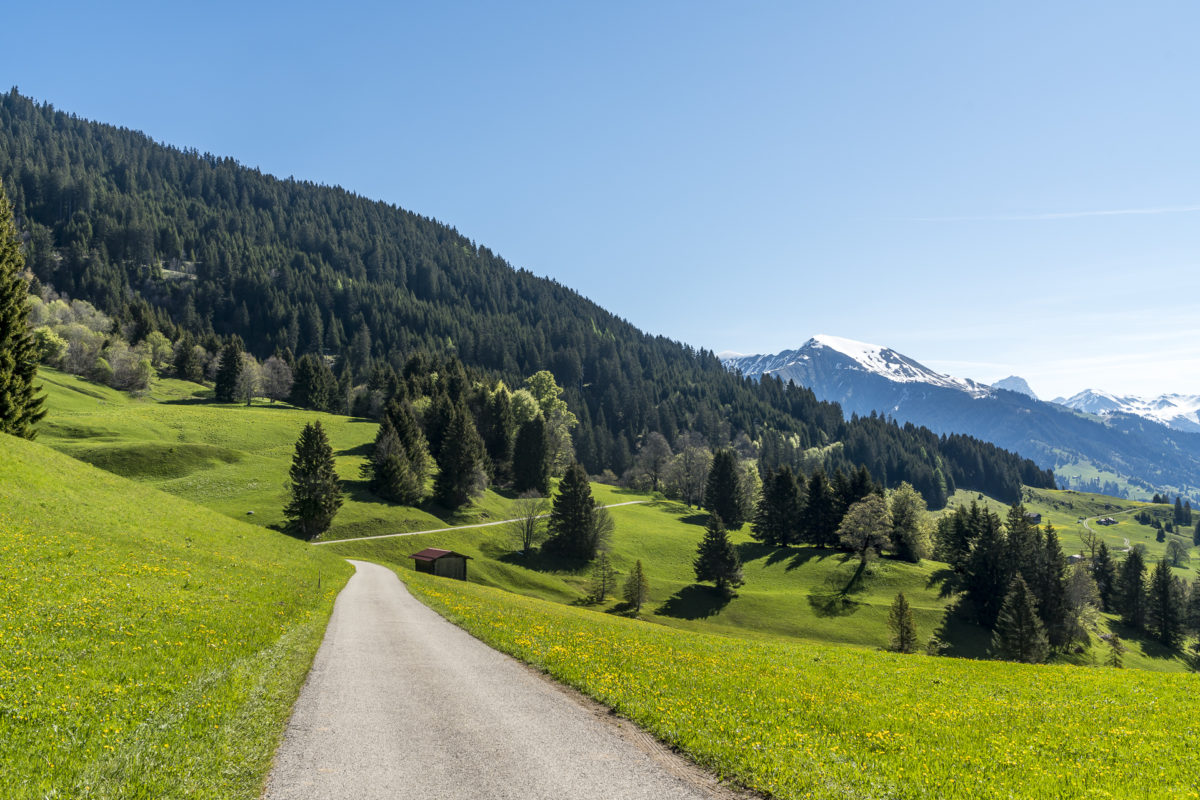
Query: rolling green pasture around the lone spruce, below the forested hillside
38,369,520,539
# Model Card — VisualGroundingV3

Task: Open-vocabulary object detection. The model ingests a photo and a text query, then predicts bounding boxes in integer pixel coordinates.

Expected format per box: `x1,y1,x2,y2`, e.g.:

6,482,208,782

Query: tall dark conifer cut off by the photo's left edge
0,184,46,439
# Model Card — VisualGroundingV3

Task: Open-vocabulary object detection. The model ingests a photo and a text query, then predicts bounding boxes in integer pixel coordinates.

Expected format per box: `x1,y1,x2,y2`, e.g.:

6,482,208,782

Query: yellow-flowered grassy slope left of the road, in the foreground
0,435,350,798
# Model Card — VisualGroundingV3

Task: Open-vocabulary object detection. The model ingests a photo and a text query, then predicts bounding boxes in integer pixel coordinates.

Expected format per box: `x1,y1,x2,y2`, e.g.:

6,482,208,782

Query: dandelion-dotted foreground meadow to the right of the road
401,571,1200,800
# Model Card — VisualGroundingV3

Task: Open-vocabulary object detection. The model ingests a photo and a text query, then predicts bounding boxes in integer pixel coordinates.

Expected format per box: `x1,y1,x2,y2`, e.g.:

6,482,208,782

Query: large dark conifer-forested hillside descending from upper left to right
0,89,1054,506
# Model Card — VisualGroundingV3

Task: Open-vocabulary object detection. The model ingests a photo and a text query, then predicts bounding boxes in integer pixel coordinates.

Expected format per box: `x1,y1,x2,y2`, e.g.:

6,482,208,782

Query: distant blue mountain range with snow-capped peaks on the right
721,335,1200,498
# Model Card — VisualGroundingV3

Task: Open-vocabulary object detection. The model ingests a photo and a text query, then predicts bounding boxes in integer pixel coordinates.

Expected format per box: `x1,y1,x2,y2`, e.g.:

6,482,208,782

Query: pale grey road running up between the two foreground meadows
264,561,739,800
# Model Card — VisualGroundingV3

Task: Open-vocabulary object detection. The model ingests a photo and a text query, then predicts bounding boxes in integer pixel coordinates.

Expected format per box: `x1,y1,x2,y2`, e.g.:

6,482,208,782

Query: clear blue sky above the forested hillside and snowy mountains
0,0,1200,397
